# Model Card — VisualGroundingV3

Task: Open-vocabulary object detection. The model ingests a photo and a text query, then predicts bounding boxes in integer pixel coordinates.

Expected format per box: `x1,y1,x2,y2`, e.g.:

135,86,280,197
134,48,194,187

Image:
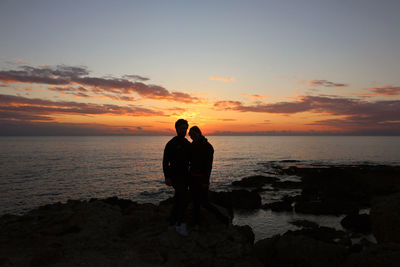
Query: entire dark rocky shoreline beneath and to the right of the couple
0,166,400,266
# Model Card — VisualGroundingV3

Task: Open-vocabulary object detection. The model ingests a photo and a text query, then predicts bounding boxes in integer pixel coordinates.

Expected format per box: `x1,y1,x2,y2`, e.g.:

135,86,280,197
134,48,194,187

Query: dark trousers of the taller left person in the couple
169,184,188,225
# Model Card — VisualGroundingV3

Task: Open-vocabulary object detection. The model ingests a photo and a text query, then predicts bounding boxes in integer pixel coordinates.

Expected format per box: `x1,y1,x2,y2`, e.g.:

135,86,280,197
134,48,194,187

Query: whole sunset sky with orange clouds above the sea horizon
0,0,400,135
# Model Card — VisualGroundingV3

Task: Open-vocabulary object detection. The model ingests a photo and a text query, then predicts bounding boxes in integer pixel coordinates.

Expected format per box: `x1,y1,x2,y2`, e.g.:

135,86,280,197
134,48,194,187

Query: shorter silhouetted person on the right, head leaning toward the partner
189,126,230,228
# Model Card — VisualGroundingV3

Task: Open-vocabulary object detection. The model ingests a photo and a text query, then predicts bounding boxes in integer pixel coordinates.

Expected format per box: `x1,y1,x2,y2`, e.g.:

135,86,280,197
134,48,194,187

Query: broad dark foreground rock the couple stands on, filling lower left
0,198,254,266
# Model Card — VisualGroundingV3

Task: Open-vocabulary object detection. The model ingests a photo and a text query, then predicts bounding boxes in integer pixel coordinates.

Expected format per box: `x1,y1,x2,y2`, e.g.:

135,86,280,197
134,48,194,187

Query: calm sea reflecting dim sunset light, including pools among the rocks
0,136,400,241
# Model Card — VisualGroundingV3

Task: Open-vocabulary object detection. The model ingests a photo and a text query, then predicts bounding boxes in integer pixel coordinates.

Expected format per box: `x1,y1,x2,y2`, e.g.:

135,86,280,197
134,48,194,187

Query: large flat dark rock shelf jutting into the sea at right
289,165,400,209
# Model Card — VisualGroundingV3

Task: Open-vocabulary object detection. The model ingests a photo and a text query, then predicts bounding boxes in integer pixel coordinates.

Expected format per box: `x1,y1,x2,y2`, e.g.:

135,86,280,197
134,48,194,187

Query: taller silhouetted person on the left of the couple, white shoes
163,119,191,235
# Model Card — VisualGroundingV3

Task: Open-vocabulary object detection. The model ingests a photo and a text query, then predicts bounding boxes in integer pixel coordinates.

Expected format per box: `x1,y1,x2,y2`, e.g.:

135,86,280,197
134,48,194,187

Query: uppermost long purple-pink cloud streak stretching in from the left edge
0,65,201,103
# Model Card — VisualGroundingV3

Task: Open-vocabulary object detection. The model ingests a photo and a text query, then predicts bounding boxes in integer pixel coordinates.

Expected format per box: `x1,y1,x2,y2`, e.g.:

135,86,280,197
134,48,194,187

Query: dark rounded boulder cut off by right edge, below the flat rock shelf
370,194,400,243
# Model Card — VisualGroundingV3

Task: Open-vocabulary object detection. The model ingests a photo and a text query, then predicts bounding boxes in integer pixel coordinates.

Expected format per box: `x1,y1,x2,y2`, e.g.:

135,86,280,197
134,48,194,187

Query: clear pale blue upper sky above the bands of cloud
0,0,400,136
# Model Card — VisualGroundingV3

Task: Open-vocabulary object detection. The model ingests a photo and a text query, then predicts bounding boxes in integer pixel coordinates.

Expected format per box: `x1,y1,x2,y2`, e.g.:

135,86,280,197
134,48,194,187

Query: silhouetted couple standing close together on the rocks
163,119,230,235
